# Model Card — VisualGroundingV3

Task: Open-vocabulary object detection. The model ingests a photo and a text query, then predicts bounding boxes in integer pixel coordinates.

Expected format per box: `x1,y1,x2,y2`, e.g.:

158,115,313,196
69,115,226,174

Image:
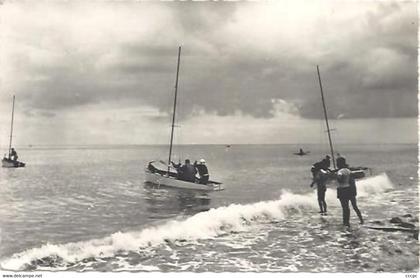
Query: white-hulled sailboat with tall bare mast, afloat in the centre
145,47,224,191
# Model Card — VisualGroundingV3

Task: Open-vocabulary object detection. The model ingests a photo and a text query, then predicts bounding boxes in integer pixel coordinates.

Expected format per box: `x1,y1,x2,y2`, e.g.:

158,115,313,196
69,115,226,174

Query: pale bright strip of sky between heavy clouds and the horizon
0,100,417,149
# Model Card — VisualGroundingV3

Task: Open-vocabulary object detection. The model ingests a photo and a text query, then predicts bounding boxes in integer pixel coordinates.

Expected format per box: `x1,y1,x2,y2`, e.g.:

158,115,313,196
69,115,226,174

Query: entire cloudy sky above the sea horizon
0,0,418,146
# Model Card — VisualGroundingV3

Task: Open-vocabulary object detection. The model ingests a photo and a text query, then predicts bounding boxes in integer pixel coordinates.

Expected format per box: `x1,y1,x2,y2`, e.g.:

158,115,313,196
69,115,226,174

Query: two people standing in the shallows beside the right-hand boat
310,155,363,226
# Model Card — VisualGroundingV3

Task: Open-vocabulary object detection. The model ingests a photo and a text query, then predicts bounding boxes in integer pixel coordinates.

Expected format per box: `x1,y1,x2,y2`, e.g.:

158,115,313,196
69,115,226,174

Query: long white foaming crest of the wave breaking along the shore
0,174,392,270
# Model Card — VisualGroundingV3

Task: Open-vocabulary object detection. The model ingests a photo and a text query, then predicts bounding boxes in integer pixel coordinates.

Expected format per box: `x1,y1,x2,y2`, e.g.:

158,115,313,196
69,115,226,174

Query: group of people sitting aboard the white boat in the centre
171,159,210,184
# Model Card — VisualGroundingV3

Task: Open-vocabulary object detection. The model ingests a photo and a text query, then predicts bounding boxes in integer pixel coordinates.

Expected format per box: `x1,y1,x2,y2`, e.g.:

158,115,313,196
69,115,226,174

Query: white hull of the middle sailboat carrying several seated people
145,169,224,191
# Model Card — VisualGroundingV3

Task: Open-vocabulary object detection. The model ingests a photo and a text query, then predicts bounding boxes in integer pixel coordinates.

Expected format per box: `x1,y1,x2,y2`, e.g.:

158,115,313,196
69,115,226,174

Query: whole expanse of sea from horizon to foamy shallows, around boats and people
0,145,419,272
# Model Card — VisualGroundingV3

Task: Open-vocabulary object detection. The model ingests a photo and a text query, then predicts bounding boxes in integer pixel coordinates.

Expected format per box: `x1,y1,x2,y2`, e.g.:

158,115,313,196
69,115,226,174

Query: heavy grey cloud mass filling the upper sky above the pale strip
0,1,417,119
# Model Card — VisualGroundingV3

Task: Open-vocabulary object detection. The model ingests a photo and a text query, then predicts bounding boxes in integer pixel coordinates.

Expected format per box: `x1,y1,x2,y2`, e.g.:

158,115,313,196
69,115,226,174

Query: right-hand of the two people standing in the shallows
336,156,363,227
